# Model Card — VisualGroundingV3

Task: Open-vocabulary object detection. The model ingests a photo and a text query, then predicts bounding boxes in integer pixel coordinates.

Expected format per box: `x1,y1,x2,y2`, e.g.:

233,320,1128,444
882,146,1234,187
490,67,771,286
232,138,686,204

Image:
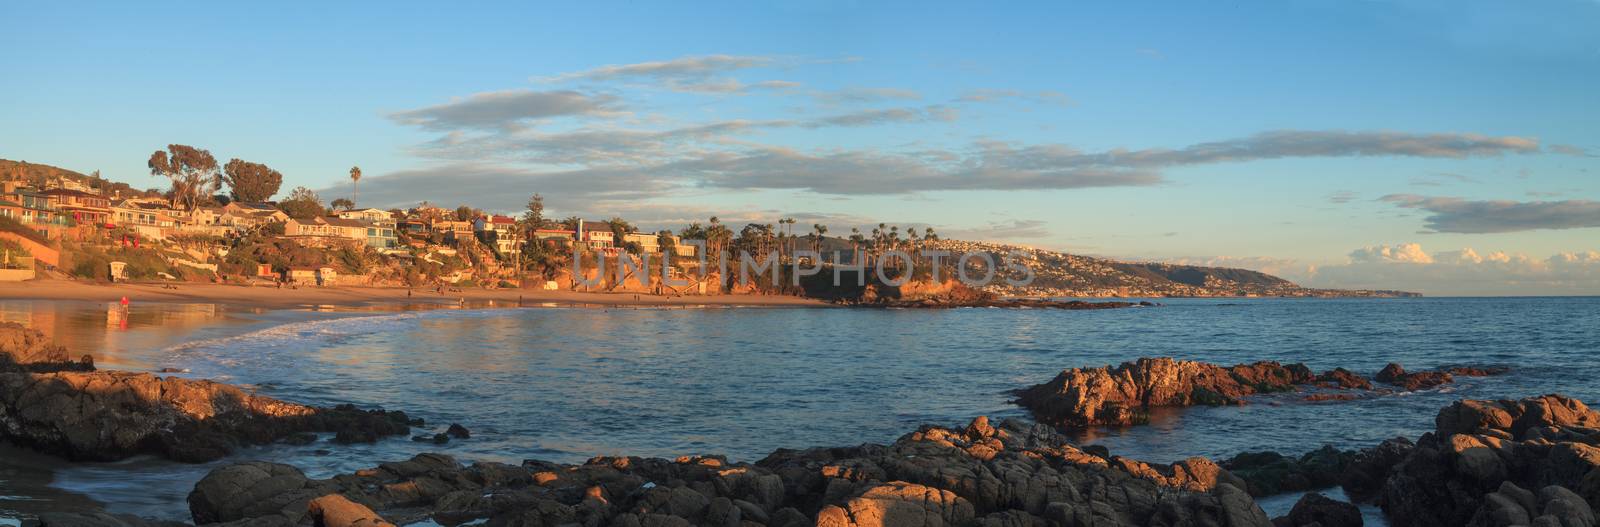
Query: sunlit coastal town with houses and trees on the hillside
0,154,1410,298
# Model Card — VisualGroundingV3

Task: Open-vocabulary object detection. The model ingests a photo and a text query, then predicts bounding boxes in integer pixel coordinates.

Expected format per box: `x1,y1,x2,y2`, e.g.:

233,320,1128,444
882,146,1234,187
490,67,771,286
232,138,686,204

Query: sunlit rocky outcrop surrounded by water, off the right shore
1014,357,1507,428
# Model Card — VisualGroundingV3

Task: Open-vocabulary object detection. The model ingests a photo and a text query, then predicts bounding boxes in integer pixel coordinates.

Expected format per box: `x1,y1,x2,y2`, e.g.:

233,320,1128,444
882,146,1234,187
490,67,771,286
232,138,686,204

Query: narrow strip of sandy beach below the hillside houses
0,280,830,309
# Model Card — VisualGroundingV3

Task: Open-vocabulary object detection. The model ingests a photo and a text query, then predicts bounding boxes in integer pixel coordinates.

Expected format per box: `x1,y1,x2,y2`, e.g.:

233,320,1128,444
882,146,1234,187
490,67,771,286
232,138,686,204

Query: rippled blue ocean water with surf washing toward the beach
0,298,1600,519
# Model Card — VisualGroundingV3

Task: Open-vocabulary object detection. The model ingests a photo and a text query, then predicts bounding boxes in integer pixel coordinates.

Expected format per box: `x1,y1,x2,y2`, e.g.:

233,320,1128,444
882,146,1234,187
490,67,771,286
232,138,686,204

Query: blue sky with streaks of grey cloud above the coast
0,0,1600,293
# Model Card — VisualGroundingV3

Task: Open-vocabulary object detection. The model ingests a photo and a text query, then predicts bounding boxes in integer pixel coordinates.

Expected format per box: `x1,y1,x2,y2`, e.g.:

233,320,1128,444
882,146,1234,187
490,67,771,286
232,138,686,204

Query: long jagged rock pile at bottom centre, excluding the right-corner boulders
190,418,1269,527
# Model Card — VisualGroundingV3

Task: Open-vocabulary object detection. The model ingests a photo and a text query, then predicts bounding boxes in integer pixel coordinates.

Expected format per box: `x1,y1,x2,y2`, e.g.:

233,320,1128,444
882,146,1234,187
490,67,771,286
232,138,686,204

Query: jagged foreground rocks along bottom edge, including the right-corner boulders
37,396,1600,527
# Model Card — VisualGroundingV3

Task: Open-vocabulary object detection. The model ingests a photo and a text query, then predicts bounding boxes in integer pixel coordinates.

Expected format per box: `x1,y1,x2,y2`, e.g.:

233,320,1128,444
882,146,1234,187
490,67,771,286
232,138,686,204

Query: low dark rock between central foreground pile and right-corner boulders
1219,445,1357,497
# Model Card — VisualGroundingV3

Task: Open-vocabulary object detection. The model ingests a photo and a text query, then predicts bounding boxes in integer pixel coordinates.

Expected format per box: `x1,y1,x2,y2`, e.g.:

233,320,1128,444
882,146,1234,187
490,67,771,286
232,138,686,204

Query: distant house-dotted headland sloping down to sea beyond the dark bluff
938,240,1418,296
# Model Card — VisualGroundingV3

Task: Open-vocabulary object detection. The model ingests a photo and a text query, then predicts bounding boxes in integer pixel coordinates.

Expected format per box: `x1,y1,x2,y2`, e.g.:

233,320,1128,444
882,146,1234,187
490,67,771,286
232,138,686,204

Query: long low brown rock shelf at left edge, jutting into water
0,372,408,461
